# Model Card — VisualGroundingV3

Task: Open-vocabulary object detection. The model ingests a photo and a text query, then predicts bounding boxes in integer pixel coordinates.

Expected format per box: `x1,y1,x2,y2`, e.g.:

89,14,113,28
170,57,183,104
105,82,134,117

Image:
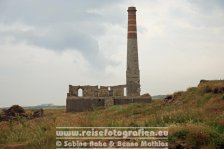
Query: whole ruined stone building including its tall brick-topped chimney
66,7,151,112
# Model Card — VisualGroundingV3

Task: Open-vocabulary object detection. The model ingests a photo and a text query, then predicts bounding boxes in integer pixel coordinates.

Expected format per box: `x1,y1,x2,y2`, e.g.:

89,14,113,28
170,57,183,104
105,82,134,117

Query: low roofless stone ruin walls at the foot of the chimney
66,85,151,112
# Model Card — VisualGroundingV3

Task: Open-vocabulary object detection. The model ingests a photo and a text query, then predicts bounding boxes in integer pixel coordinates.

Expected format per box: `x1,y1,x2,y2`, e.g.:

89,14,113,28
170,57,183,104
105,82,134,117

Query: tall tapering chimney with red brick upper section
126,7,140,96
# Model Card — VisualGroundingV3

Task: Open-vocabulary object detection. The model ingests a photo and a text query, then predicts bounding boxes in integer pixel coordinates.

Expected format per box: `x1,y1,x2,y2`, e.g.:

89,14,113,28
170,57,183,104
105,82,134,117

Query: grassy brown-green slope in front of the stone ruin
0,83,224,149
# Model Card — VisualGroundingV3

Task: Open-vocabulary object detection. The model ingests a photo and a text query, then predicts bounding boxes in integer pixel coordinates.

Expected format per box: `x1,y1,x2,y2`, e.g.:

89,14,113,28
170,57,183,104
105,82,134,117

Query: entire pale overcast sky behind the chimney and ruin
0,0,224,107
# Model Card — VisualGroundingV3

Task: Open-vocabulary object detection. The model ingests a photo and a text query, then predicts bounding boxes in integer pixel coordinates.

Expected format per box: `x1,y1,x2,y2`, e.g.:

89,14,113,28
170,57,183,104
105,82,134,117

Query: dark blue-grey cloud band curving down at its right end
0,25,107,69
